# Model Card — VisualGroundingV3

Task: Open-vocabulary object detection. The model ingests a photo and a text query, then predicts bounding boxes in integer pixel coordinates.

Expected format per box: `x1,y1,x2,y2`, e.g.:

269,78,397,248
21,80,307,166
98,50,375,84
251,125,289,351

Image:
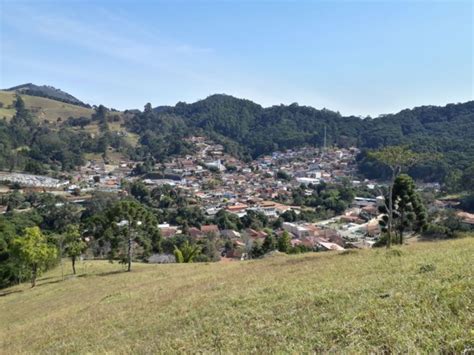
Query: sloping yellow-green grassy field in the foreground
0,238,474,354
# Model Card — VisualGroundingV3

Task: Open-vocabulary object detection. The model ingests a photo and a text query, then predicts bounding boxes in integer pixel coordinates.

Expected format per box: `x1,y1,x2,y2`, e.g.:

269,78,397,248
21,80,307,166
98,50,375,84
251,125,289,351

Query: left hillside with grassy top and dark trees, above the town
0,91,139,174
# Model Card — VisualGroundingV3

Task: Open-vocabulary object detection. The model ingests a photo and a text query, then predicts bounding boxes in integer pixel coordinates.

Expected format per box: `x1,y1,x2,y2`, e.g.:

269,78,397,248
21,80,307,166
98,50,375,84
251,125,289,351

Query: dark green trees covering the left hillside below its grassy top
0,96,130,174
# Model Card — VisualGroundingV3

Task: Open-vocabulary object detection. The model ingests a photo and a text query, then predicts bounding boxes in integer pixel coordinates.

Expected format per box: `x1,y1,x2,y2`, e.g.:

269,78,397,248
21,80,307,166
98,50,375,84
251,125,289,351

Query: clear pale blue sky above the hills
0,0,474,116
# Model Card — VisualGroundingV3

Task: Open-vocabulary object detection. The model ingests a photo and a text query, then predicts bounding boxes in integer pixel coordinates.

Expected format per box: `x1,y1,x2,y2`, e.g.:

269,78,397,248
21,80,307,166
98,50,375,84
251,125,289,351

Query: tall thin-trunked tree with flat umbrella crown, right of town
370,146,425,248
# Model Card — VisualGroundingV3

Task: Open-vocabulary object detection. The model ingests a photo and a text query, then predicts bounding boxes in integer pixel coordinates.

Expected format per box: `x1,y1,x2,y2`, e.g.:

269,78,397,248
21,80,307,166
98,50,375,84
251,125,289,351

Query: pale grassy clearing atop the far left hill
0,91,93,122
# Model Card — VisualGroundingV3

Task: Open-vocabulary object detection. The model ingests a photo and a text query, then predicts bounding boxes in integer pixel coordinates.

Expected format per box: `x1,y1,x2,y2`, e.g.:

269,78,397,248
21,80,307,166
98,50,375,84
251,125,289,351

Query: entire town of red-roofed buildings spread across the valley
0,136,474,261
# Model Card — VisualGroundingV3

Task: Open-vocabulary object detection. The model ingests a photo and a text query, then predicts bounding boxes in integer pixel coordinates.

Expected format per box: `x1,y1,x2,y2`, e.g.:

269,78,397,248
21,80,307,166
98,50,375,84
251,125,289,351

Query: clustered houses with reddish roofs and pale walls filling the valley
0,137,474,257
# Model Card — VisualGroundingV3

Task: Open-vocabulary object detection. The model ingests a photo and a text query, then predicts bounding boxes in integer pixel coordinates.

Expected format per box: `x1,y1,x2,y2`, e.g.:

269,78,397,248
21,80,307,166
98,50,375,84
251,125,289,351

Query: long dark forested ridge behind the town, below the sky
129,95,474,181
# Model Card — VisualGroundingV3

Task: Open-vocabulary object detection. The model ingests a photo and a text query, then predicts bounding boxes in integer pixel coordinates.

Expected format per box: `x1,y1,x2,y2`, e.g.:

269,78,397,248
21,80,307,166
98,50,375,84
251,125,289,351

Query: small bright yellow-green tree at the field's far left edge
15,227,57,287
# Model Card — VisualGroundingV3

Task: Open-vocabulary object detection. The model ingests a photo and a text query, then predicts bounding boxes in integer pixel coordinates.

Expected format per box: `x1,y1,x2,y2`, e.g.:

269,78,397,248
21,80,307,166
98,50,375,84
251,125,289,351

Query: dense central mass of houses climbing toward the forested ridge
135,137,359,217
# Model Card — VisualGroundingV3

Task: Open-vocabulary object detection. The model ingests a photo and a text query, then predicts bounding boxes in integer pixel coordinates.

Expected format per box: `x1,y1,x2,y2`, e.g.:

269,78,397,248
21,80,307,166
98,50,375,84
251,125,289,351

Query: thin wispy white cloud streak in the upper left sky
4,6,213,74
